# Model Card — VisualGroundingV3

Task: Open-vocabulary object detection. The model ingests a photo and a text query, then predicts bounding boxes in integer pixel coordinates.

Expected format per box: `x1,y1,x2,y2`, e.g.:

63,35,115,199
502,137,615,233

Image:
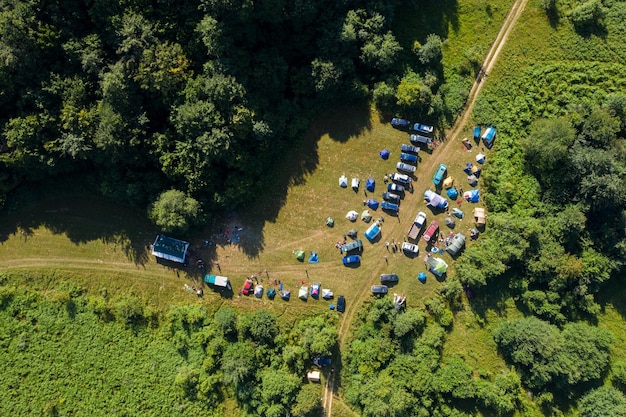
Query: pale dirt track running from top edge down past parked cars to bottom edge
322,0,528,417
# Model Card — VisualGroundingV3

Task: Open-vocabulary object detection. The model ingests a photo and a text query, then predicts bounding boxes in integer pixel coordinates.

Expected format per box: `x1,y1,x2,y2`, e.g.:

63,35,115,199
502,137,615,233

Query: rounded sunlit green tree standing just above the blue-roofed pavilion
150,190,200,233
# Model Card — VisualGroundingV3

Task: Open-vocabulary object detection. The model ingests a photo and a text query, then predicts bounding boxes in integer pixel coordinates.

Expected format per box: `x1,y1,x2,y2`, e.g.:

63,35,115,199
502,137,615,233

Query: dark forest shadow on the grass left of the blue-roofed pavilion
0,181,151,265
